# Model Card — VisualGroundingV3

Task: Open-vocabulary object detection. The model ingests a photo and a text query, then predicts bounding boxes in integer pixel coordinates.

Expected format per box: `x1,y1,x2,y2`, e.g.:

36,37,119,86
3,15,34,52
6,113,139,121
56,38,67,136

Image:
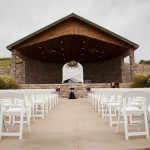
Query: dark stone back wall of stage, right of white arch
83,59,122,83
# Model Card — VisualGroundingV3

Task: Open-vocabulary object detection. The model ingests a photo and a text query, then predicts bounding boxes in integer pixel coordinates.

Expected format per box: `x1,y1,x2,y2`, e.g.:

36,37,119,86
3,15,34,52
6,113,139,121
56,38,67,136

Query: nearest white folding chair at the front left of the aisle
0,91,30,139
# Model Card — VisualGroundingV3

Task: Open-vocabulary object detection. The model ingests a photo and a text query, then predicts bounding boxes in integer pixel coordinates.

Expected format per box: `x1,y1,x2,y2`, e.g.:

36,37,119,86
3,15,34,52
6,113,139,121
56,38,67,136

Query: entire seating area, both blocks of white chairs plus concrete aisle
0,88,150,150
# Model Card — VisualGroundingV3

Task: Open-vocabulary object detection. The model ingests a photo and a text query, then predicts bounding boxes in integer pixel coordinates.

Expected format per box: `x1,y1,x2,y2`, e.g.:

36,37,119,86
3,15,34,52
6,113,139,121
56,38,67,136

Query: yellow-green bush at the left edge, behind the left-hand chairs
0,75,19,89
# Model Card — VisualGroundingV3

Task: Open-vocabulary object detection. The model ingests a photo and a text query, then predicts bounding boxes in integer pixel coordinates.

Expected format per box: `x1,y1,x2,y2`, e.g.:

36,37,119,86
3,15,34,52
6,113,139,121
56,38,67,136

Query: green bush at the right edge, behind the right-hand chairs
131,74,150,88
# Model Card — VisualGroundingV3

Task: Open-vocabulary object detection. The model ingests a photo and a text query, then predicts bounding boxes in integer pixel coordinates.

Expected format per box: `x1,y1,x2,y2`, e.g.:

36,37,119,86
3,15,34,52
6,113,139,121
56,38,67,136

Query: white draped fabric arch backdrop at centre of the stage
62,63,83,83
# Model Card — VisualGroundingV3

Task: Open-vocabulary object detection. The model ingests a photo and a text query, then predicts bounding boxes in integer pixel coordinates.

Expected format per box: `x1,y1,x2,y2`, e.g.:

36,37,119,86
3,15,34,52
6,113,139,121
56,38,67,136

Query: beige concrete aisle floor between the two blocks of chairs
0,98,150,150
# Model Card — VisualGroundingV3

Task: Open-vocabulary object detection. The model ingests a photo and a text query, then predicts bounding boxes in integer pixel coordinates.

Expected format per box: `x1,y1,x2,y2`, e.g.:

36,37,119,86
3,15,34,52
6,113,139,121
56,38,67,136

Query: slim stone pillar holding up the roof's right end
129,48,135,82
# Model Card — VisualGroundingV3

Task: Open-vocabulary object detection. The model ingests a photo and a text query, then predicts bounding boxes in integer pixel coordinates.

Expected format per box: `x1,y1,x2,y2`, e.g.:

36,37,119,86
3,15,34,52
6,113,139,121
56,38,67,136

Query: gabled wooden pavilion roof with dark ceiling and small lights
7,13,139,63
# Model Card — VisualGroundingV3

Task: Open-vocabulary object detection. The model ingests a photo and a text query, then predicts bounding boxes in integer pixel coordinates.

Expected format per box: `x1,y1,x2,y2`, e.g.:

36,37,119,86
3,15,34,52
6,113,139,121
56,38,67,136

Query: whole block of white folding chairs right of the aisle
88,88,150,140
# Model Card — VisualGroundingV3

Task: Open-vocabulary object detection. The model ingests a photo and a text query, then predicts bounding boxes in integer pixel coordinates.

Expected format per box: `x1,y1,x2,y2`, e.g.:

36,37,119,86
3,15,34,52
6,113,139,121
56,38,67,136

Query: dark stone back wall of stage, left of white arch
25,59,63,84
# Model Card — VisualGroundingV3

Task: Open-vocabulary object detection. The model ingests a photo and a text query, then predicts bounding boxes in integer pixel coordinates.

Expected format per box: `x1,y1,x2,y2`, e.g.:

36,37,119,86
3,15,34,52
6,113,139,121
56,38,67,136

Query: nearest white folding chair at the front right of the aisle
116,90,149,140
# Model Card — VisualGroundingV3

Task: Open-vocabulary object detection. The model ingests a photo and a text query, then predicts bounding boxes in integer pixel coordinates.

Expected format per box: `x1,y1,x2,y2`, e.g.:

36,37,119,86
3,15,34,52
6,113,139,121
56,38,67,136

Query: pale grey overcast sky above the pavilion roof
0,0,150,63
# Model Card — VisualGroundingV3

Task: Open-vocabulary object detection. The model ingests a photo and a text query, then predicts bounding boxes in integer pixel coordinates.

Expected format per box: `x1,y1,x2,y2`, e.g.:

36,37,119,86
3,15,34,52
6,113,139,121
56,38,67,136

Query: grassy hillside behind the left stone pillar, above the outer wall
0,58,22,67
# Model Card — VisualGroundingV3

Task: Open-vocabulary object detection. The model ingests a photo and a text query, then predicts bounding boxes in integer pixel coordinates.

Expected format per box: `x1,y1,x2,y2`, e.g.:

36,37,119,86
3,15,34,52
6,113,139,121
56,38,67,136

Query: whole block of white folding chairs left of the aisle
0,89,58,139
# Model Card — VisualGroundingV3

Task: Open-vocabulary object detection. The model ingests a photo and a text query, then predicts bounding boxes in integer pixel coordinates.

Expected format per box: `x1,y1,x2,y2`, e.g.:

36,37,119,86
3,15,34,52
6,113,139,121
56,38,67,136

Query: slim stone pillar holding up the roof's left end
11,50,16,79
